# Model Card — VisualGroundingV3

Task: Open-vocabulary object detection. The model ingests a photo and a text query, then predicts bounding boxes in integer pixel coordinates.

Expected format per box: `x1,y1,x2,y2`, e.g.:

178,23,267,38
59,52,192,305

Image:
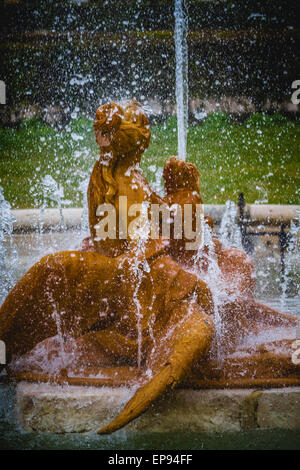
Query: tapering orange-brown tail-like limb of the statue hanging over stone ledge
98,301,213,434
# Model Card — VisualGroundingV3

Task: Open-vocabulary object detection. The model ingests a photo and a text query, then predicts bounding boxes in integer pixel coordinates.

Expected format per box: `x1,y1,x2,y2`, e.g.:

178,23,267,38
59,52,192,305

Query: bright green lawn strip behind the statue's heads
0,113,300,208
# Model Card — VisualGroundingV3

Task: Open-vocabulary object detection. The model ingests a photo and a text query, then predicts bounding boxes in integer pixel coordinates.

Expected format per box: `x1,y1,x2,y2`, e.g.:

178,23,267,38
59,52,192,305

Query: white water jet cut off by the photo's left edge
0,186,18,305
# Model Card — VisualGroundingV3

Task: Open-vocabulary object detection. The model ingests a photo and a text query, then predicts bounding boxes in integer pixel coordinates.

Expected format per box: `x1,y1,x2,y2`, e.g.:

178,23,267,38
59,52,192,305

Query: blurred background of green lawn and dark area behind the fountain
0,0,300,208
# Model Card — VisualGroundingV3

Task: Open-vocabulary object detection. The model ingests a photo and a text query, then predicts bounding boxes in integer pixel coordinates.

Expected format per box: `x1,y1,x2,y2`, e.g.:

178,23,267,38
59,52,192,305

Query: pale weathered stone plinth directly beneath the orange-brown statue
11,382,300,434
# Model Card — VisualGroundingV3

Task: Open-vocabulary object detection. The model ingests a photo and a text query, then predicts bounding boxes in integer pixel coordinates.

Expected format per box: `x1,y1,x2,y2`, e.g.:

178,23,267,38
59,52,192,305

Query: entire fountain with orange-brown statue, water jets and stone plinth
0,0,300,445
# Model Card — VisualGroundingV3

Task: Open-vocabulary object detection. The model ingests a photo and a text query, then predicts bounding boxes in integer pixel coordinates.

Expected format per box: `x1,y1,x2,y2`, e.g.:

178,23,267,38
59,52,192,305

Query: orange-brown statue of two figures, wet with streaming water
0,100,300,434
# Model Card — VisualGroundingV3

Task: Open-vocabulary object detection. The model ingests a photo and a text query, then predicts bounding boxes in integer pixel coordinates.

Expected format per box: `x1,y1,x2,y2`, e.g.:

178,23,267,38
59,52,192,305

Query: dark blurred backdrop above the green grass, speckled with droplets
0,0,300,124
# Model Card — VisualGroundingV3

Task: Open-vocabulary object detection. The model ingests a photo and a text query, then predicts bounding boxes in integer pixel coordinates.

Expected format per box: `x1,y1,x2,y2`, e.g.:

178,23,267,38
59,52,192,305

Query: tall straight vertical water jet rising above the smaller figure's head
175,0,188,160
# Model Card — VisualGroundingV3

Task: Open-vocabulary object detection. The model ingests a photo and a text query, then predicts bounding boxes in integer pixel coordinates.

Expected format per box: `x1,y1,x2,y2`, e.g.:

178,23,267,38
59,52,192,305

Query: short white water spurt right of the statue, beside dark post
219,201,243,249
